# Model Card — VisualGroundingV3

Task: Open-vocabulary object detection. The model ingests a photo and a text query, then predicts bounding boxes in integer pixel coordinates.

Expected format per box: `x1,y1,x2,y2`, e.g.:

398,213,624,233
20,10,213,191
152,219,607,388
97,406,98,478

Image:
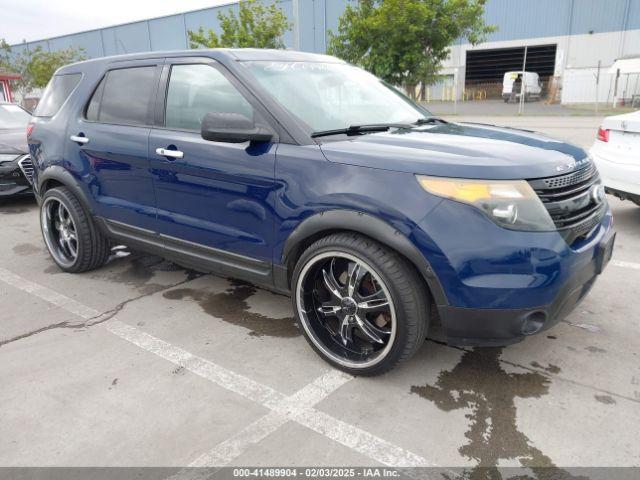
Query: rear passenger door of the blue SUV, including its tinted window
66,59,164,231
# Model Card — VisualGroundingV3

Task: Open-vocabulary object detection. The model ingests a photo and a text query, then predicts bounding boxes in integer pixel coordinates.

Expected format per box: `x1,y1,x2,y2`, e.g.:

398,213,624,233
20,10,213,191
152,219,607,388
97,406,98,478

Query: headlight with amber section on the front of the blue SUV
417,175,556,231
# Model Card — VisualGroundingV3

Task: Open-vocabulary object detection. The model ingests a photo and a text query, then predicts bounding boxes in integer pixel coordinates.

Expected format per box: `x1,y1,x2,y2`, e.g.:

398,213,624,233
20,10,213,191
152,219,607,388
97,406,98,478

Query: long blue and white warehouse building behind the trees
14,0,640,103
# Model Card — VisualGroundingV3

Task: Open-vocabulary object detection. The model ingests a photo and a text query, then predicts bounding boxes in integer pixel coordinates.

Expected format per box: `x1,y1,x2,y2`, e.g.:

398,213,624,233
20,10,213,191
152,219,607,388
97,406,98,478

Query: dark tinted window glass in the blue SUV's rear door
86,66,156,125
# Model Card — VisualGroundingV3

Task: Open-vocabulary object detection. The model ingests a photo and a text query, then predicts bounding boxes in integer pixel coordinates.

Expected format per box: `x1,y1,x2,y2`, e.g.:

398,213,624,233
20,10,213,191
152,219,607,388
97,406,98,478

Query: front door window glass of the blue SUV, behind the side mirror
165,65,253,131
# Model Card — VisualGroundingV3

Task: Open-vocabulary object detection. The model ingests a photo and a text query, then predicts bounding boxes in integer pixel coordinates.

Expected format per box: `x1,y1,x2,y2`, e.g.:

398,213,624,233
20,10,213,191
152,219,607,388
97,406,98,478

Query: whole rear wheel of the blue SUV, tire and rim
40,187,109,273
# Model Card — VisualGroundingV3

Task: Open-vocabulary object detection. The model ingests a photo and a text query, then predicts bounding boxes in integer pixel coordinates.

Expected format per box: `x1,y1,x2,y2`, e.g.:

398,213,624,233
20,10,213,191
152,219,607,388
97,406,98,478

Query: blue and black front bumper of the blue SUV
415,198,615,346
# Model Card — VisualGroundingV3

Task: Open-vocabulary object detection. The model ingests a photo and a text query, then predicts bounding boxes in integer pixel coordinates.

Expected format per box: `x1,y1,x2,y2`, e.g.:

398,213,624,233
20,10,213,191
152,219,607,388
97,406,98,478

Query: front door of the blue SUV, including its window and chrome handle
149,58,277,283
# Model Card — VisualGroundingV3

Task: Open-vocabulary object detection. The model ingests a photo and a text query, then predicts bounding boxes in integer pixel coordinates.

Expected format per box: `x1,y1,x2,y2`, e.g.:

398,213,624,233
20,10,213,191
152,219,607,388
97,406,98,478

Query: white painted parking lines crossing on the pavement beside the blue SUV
0,267,435,467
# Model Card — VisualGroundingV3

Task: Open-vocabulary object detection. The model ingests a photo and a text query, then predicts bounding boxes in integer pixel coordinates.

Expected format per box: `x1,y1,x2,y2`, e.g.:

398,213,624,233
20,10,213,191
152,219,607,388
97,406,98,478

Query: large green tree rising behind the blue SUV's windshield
328,0,496,96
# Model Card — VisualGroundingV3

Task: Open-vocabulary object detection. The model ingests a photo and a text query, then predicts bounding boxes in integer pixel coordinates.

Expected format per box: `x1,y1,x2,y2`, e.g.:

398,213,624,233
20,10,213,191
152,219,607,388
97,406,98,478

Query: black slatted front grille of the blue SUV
529,163,606,244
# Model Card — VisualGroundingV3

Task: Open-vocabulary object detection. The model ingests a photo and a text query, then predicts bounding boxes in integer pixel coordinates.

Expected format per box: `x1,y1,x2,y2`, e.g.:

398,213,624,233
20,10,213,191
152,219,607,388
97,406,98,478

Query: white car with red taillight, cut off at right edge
590,110,640,205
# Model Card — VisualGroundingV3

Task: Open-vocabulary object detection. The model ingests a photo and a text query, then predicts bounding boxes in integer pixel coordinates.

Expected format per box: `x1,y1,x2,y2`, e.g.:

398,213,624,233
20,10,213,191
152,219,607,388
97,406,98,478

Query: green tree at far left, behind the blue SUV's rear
0,39,85,97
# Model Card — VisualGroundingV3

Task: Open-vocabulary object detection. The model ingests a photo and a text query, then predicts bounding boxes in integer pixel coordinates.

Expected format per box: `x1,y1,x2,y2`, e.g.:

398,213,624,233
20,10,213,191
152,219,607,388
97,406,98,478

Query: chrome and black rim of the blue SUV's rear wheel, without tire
40,197,78,267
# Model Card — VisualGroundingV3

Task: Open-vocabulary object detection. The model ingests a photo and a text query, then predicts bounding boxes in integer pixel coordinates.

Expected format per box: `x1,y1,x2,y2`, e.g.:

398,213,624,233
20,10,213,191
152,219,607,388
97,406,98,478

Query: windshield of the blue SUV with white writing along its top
245,61,430,132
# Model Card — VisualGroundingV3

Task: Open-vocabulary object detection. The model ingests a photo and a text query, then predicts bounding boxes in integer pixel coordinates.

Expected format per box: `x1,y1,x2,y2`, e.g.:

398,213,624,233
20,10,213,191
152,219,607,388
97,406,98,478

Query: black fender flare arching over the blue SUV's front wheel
276,210,448,305
